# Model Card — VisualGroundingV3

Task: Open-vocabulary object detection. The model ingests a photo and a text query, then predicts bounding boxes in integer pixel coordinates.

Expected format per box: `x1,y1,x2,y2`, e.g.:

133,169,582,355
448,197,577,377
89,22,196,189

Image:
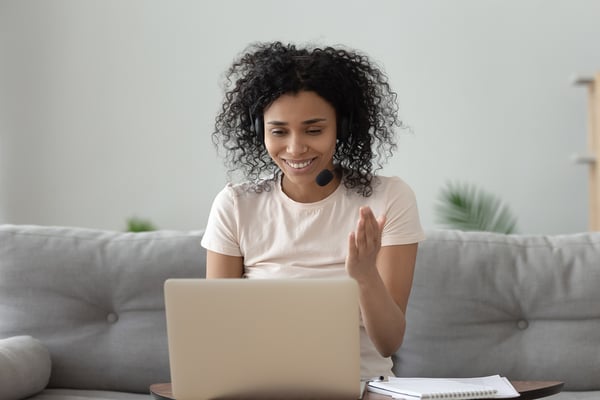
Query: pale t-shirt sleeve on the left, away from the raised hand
202,185,242,257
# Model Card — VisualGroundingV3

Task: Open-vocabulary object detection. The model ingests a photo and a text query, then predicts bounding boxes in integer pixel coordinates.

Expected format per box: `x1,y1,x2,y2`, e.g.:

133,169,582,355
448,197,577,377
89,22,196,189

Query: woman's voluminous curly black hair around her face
212,42,402,196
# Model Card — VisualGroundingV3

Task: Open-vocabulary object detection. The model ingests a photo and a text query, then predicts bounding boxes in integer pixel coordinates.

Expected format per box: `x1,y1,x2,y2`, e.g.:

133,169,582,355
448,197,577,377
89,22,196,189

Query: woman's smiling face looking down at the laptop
264,91,337,198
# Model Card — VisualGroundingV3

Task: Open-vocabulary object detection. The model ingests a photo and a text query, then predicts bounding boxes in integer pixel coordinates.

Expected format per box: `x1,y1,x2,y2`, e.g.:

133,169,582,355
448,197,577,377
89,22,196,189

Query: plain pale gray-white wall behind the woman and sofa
0,0,600,233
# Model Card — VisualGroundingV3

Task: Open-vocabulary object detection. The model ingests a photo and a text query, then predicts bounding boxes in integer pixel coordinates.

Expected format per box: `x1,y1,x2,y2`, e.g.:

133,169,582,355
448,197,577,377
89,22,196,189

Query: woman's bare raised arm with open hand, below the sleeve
346,207,418,357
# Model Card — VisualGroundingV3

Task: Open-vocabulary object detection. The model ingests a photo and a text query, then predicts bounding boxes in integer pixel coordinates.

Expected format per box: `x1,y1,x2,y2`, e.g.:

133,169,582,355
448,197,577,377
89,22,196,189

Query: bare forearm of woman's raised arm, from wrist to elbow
357,268,406,357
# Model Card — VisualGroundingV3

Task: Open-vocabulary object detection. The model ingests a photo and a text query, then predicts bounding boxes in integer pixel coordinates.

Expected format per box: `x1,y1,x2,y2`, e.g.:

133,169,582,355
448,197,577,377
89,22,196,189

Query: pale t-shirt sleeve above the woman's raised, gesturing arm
381,177,425,246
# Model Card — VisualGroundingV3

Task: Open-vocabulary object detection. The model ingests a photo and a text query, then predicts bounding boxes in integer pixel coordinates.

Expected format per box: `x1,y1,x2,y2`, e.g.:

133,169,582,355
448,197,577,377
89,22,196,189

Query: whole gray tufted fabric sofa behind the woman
0,225,600,400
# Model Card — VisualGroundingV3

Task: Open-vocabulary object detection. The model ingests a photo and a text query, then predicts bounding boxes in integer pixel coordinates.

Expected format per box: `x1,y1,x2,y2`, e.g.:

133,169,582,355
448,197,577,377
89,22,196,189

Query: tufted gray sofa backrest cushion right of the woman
394,230,600,390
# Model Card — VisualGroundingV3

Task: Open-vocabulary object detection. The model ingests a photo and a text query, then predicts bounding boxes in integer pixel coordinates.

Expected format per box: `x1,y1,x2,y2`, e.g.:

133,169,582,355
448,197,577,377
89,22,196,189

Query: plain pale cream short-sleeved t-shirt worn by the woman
202,177,425,379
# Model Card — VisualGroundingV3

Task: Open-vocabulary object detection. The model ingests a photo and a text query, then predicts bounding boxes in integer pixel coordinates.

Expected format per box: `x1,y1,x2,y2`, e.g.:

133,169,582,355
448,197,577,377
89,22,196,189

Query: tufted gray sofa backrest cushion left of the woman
0,225,206,393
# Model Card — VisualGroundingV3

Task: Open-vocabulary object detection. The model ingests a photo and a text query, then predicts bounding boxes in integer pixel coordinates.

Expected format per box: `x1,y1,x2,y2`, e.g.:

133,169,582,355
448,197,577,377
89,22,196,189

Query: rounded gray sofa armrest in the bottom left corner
0,336,52,400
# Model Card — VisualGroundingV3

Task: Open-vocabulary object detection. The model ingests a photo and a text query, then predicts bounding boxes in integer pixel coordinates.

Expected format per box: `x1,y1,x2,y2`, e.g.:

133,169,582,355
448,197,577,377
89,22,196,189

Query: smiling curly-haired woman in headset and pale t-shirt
202,42,424,378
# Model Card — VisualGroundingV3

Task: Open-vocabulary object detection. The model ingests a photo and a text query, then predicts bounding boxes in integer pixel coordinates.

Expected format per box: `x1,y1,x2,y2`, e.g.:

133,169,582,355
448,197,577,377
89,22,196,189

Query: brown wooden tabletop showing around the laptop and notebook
150,381,563,400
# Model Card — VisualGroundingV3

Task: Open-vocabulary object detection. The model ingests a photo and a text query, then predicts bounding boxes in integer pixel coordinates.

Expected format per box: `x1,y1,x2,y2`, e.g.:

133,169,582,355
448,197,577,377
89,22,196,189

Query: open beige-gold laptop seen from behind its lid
165,278,363,400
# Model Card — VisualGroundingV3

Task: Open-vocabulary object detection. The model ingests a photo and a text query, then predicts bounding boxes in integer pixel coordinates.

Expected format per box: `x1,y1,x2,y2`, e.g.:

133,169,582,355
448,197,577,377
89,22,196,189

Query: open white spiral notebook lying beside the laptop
368,375,519,400
